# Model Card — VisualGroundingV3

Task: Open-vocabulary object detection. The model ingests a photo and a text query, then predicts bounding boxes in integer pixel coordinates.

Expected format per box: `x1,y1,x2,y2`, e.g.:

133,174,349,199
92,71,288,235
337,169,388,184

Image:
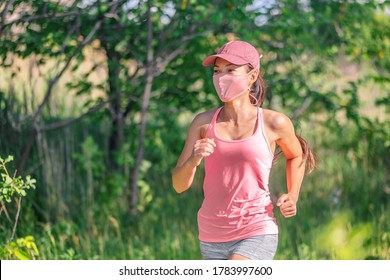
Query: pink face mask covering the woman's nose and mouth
213,72,251,102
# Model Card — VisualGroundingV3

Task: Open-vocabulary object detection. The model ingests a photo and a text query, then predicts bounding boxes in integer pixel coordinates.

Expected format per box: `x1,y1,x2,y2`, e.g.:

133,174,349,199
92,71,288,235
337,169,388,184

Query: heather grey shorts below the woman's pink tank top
200,234,278,260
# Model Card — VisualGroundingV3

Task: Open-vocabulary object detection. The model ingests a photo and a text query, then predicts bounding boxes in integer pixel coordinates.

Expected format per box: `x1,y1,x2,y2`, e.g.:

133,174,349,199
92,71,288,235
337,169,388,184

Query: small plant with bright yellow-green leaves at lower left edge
0,156,39,260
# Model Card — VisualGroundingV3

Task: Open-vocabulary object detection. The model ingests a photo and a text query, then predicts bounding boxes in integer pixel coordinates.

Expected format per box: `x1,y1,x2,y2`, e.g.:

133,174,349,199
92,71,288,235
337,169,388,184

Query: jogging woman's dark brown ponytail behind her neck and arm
246,64,316,174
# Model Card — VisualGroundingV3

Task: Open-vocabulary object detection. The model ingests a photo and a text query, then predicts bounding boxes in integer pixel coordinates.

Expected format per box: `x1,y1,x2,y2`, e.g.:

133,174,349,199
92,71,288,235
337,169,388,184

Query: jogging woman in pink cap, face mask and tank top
172,41,314,260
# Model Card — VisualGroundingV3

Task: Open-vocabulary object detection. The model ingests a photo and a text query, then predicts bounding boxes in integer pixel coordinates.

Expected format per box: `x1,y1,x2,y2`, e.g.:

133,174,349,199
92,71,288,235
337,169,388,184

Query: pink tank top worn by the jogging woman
198,107,278,242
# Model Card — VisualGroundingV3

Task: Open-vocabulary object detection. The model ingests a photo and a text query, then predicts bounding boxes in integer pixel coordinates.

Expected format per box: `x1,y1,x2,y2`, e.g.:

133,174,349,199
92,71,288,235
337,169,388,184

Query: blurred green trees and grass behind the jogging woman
0,0,390,260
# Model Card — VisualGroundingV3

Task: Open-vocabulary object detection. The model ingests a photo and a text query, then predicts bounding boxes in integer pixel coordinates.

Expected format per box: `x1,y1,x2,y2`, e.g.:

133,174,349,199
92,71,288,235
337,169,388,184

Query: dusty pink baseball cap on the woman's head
202,41,261,68
